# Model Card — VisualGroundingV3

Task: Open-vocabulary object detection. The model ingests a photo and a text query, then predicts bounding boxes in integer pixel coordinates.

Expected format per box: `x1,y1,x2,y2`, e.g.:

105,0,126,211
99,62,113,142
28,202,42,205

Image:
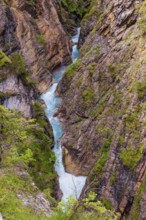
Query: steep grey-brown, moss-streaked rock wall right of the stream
58,0,146,220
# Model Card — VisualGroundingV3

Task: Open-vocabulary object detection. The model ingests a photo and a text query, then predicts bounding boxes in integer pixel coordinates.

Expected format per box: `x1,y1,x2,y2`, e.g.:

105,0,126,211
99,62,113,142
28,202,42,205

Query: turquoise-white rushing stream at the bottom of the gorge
41,28,86,200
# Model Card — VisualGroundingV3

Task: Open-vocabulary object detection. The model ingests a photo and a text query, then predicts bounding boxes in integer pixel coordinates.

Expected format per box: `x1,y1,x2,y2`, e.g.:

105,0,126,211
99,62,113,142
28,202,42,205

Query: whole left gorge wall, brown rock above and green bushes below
0,0,71,219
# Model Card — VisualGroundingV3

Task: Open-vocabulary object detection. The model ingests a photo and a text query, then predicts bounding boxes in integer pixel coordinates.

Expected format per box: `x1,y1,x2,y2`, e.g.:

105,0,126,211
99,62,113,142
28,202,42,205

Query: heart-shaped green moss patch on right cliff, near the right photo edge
120,146,144,171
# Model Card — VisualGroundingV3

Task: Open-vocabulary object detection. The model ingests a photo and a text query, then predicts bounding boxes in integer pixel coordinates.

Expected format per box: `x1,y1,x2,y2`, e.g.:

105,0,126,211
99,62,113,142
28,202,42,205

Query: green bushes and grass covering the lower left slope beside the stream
0,106,56,219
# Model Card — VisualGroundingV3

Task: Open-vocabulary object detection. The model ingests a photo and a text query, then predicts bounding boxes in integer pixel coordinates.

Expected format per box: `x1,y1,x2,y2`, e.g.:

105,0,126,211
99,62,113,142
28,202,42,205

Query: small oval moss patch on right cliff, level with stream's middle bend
82,87,96,105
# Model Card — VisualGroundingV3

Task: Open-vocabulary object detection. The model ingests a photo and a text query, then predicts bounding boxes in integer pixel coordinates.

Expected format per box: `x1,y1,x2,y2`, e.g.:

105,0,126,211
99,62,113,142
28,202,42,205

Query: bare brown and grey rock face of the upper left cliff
0,0,71,118
